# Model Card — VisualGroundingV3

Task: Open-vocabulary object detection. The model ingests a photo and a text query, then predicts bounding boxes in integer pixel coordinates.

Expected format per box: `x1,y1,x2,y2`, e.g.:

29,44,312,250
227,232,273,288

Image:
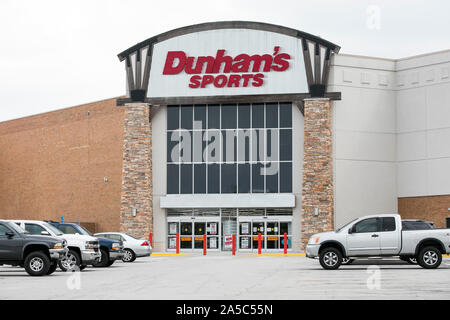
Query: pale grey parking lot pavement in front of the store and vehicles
0,255,450,299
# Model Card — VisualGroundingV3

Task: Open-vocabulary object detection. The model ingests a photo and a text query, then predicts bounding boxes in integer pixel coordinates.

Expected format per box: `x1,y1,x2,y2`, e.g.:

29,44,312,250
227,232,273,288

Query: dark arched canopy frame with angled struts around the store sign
117,21,340,105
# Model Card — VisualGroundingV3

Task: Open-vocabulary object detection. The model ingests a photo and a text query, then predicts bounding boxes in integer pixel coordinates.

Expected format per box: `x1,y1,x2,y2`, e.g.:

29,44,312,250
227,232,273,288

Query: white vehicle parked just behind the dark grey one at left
10,220,101,271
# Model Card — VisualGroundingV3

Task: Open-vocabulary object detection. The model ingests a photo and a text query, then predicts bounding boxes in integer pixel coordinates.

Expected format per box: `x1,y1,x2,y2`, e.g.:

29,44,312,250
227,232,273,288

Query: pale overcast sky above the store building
0,0,450,121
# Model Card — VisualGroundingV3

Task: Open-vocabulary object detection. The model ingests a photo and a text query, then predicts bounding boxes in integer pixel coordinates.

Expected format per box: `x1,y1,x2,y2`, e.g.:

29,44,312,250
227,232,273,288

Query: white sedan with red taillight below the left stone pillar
94,232,152,262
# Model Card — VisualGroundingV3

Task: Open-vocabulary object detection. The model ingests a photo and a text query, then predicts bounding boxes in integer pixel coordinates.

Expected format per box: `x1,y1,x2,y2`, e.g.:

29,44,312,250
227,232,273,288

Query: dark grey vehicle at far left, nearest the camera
0,220,68,276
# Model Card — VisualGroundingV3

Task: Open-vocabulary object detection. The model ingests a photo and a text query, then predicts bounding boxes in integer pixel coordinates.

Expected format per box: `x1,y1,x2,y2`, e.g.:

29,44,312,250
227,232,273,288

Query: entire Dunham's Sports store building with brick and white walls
0,21,450,251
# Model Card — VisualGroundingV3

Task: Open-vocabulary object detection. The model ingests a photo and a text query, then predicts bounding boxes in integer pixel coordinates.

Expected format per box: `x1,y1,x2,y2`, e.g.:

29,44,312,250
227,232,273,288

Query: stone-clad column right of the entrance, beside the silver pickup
301,98,334,250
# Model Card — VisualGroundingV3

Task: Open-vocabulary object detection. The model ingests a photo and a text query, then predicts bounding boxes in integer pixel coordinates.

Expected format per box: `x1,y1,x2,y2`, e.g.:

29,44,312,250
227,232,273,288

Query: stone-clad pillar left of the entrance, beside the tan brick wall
120,103,153,239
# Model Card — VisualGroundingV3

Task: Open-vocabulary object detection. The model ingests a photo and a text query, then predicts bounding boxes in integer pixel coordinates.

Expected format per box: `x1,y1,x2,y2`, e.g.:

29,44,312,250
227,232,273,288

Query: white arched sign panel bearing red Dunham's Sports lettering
148,29,308,98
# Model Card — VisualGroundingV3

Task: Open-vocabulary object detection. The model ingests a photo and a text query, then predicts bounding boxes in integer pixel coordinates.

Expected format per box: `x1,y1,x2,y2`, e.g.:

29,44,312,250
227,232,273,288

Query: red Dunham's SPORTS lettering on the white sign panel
163,46,291,89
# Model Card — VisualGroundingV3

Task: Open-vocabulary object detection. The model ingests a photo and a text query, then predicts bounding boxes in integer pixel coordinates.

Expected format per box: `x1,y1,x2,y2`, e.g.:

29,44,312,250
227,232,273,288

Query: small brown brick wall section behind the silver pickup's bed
398,195,450,228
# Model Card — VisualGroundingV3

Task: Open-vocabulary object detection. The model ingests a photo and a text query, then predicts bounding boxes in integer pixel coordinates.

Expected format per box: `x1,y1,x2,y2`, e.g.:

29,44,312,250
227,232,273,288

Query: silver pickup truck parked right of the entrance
306,214,450,270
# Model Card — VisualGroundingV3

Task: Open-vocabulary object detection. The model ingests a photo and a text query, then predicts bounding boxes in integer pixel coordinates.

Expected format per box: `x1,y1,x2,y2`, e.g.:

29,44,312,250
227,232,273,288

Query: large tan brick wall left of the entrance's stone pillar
0,98,124,232
